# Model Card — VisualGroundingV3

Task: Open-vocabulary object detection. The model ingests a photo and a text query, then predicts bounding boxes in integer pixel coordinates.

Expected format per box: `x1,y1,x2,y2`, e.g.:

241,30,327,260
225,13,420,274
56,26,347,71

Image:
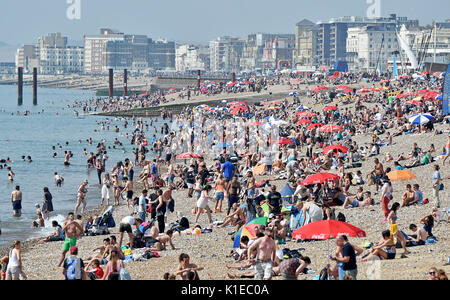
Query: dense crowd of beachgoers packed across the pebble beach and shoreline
1,69,450,280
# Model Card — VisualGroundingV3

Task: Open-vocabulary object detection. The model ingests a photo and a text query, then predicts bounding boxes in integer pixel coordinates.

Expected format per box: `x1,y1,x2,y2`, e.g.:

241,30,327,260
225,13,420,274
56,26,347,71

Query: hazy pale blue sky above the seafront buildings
0,0,450,58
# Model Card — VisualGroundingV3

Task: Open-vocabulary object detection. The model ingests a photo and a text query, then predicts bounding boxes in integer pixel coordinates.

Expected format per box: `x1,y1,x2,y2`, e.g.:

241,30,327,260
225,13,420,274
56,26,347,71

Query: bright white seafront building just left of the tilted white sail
346,25,399,72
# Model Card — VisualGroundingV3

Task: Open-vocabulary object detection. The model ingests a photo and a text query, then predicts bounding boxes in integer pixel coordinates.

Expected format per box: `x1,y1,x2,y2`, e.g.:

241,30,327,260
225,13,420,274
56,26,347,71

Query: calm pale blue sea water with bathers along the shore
0,86,161,245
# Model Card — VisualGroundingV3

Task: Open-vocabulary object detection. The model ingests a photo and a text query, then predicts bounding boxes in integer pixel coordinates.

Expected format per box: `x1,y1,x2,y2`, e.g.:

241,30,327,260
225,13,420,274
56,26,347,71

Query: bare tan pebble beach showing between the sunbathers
7,81,450,280
